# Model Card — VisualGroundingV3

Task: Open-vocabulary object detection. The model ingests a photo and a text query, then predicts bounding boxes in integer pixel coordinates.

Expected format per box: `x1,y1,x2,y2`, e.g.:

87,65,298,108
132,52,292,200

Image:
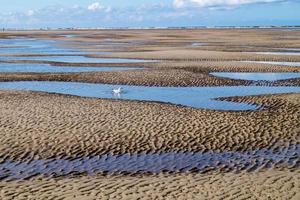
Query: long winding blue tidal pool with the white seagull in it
0,81,300,110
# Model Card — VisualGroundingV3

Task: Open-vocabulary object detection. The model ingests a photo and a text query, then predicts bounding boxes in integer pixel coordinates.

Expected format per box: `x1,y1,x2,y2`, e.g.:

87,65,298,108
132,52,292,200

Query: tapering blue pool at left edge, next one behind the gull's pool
0,63,141,73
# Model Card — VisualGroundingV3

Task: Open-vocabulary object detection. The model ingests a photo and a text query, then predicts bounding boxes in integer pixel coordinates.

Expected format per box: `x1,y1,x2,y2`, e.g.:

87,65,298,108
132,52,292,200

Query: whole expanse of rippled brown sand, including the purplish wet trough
0,29,300,200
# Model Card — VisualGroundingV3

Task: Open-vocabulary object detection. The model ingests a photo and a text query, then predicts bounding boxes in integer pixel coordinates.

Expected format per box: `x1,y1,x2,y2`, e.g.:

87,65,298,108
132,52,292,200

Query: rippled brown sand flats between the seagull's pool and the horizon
0,29,300,86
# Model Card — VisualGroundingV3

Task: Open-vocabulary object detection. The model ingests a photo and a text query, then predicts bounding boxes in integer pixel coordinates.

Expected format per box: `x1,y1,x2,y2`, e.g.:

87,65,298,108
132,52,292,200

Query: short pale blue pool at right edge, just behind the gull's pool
210,72,300,81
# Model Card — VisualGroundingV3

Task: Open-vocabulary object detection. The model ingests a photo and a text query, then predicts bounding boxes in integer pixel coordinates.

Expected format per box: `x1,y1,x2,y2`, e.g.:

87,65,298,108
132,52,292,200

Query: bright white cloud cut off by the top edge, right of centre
173,0,282,8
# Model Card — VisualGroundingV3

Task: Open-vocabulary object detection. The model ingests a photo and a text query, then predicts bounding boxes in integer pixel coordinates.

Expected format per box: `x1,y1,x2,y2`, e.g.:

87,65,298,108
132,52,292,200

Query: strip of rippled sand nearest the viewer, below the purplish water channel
0,170,300,200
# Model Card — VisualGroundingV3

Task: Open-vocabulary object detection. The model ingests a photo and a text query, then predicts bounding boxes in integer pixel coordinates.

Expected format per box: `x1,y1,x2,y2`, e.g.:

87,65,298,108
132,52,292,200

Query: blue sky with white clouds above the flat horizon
0,0,300,28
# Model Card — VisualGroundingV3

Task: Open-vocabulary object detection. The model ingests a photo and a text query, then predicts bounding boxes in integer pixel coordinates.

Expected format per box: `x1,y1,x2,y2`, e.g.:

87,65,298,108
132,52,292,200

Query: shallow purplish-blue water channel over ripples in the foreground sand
0,145,300,180
